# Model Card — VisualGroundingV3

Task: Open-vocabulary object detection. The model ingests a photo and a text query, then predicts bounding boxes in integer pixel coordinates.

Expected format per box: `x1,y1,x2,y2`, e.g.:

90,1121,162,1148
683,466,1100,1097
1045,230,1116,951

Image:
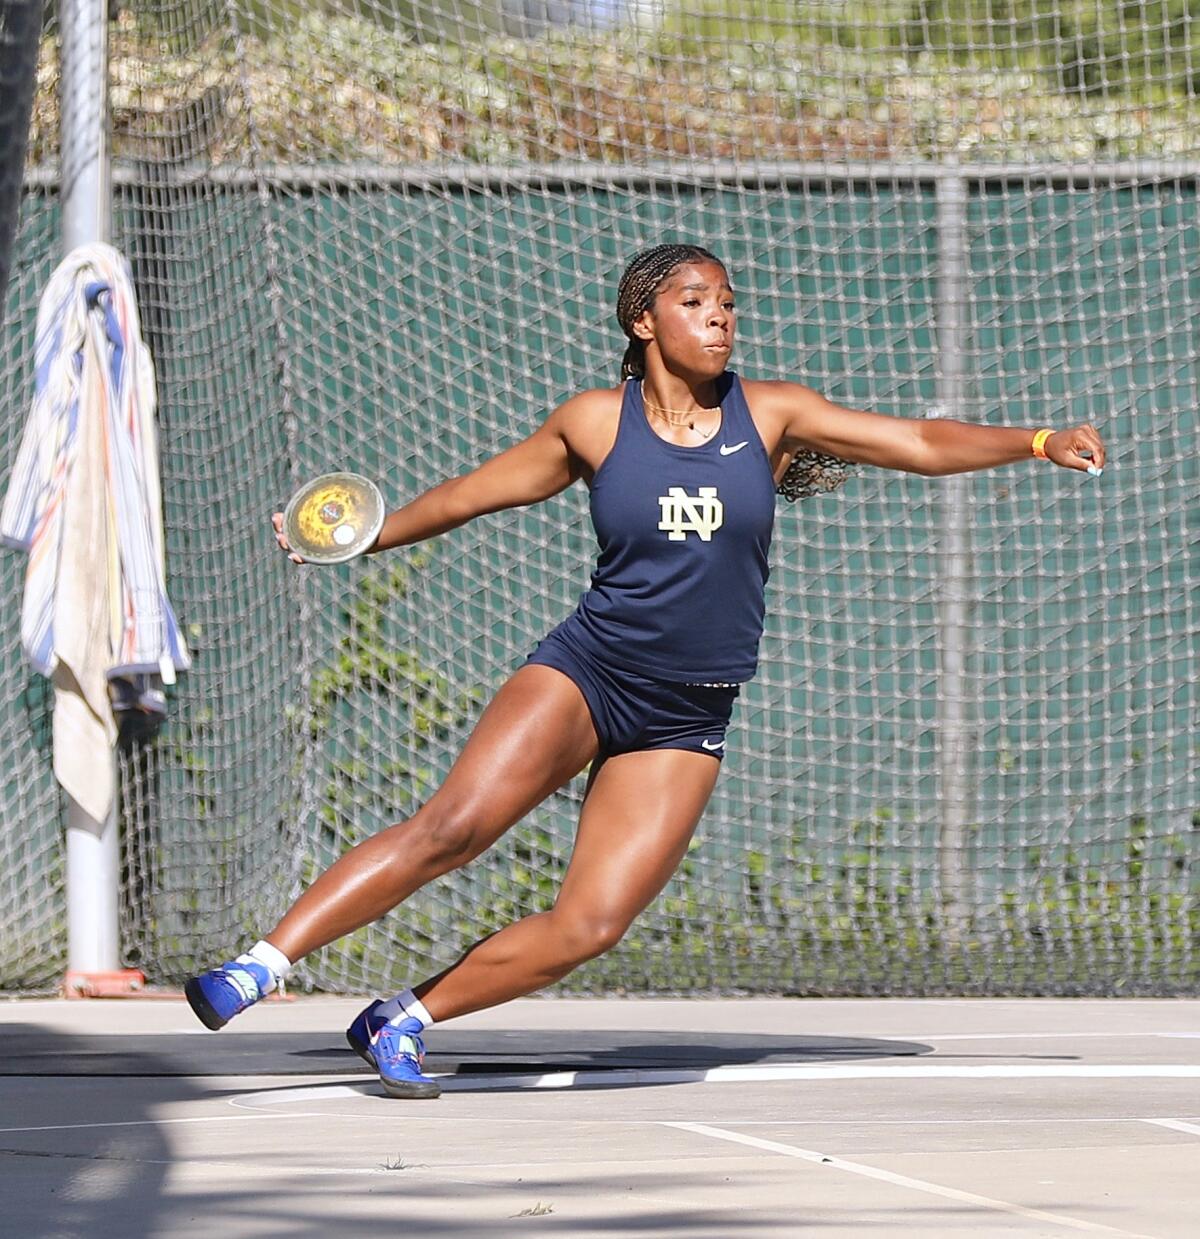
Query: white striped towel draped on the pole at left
0,245,191,820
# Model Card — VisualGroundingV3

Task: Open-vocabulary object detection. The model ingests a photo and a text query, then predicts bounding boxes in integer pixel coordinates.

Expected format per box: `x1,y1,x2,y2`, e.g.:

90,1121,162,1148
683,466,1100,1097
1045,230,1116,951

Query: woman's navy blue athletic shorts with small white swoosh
528,626,739,761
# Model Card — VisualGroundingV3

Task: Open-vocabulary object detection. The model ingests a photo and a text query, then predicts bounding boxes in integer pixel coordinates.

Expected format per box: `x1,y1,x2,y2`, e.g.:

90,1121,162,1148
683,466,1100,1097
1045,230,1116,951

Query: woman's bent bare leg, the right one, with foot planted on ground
415,748,720,1020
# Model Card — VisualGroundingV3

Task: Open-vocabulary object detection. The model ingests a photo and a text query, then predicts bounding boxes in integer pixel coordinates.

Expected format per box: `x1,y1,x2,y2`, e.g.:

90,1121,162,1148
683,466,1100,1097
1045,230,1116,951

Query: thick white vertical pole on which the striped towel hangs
59,0,120,973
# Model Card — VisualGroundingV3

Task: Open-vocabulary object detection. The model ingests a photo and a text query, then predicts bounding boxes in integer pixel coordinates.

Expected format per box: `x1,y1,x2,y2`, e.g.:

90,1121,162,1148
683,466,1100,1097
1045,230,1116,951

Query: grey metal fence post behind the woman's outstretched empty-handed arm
931,176,972,940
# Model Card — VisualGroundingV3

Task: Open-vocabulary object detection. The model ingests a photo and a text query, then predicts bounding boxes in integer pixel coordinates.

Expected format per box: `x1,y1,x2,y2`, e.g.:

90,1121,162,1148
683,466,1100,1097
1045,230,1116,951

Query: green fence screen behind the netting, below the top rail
0,182,1200,992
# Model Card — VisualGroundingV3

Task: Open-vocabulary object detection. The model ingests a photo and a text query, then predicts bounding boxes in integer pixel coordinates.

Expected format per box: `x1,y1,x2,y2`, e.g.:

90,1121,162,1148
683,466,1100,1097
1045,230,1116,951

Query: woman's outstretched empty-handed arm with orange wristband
755,383,1105,477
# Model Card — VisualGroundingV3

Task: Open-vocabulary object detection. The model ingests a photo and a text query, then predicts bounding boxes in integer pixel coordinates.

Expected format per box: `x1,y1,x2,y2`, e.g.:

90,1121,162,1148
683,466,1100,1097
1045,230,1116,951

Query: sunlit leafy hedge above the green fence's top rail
23,0,1200,171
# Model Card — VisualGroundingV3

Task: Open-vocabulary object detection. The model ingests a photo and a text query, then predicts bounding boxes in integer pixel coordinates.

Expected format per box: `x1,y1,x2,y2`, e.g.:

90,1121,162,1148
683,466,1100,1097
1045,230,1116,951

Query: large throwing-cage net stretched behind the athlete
0,0,1200,994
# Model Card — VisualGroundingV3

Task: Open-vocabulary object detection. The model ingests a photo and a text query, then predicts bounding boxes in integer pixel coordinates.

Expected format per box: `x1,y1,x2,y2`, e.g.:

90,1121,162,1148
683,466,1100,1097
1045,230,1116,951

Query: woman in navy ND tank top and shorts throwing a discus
186,245,1105,1098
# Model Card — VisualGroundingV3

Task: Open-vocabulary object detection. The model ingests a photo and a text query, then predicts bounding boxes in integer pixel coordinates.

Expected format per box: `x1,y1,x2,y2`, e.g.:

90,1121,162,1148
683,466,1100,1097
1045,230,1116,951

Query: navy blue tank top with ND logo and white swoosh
568,370,775,683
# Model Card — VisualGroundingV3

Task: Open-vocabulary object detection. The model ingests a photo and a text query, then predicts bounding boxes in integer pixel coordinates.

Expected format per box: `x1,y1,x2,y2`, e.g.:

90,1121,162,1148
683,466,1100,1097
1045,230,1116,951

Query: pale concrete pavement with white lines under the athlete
0,997,1200,1239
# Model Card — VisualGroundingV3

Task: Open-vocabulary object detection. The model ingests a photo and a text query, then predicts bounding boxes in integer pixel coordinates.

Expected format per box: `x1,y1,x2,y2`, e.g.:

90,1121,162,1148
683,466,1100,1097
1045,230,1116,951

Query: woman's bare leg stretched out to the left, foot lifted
266,664,597,963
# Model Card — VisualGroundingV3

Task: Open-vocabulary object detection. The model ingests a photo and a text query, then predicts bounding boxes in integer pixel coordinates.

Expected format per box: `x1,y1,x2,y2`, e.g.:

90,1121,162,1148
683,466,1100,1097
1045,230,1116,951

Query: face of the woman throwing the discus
634,263,737,378
